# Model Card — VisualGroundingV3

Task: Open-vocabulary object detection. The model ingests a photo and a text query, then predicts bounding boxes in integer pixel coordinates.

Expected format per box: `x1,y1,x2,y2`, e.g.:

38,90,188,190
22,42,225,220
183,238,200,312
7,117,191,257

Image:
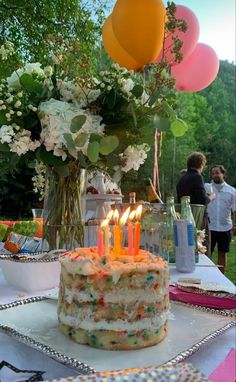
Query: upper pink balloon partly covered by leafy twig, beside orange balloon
155,5,200,65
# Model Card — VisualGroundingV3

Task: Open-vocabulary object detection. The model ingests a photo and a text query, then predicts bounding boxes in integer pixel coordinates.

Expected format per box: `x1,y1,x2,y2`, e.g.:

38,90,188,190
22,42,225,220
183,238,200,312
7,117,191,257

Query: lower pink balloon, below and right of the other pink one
171,42,220,93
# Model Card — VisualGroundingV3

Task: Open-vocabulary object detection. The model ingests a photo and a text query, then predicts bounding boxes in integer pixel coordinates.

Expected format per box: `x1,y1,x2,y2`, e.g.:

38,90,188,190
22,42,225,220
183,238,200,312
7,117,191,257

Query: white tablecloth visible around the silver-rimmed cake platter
0,255,236,378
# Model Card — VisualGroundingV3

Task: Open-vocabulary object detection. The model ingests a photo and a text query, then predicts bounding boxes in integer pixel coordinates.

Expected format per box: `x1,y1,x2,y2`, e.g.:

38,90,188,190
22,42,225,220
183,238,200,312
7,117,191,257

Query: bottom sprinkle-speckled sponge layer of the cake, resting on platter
59,322,168,350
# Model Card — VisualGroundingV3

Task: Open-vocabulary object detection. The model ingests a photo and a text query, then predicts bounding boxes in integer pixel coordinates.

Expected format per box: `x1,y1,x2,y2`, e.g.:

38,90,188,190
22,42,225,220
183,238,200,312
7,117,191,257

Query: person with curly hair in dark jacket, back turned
176,151,215,206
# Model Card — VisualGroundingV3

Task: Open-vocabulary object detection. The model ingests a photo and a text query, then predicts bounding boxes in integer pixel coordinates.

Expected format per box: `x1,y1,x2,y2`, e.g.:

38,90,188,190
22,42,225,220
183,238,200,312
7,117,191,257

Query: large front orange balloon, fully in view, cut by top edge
112,0,166,65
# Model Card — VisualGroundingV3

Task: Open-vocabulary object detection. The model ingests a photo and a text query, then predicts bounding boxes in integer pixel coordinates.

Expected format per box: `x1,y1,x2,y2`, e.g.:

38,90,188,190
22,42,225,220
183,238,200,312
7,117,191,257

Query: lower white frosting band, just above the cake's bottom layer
59,311,168,331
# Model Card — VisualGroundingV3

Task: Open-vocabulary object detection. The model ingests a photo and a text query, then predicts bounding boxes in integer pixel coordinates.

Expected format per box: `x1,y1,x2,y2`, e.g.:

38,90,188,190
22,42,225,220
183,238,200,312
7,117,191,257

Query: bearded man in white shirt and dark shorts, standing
205,165,236,273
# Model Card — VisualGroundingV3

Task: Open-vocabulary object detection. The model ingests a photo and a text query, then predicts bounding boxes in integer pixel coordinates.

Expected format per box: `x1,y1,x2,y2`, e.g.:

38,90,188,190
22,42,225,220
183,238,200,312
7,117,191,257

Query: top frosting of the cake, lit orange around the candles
60,248,168,284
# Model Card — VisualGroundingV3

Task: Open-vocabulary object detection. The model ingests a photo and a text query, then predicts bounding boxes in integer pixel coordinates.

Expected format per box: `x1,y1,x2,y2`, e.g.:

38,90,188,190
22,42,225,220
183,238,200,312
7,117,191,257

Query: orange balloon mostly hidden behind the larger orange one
102,15,143,71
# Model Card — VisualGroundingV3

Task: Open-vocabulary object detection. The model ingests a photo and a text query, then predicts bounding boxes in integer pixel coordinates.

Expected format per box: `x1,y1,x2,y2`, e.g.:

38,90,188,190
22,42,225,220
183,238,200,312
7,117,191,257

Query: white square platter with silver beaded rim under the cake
0,297,235,374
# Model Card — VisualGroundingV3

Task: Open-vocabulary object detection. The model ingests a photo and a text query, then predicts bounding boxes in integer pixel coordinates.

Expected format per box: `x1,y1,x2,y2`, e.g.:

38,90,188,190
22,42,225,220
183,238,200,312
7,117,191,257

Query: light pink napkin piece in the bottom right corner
208,349,236,382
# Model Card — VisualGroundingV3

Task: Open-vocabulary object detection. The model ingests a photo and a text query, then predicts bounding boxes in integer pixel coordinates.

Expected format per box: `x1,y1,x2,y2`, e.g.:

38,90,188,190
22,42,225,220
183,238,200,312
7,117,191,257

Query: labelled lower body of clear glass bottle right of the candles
174,219,195,273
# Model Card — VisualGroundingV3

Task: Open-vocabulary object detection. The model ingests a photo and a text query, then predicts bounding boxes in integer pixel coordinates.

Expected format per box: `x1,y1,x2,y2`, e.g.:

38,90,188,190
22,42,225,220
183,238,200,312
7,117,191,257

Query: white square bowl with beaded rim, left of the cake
0,255,61,292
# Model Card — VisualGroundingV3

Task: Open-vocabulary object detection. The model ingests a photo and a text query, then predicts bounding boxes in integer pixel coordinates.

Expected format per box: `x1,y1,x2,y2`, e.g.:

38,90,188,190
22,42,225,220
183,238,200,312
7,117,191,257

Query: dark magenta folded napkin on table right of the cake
169,286,236,309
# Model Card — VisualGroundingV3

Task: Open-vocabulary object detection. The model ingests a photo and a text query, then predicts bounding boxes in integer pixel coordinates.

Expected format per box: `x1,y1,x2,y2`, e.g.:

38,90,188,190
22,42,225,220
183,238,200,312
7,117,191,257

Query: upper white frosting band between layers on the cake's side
65,287,168,304
